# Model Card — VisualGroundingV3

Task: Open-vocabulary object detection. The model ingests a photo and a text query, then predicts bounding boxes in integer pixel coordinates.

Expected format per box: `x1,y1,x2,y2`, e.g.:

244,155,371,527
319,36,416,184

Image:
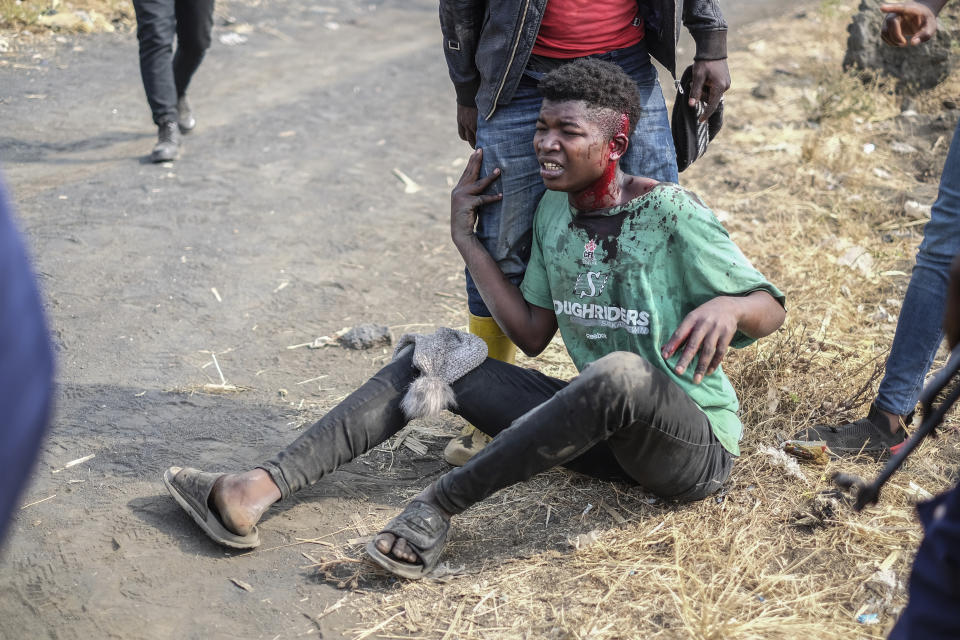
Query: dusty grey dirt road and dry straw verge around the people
0,0,957,639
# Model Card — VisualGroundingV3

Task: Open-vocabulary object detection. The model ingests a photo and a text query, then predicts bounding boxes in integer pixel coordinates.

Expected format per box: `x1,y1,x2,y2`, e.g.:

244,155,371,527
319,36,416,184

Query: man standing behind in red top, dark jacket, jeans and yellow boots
440,0,730,465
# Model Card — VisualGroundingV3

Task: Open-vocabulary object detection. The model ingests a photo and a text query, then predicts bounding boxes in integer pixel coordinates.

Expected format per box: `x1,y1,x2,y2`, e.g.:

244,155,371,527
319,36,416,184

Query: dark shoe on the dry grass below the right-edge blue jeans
793,405,913,460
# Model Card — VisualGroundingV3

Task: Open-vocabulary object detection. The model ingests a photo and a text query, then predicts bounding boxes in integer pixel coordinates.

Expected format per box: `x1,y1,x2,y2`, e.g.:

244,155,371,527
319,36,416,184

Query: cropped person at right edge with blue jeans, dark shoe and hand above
794,0,960,458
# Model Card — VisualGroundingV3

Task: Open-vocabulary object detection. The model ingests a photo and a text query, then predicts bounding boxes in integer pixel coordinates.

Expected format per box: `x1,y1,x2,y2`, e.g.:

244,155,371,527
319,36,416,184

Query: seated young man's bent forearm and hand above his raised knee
661,291,786,384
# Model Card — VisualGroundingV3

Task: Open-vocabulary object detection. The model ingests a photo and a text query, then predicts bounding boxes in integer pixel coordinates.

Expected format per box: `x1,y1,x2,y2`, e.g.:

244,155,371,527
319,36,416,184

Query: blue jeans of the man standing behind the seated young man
467,42,677,317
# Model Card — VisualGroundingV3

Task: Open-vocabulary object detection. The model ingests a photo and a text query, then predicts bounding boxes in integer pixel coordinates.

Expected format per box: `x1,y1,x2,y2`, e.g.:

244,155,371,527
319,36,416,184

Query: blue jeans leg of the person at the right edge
875,125,960,416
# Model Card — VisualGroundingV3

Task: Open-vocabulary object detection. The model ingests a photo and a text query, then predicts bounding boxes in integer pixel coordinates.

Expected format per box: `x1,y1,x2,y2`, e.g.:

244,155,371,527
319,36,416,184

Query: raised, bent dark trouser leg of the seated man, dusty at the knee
436,352,733,513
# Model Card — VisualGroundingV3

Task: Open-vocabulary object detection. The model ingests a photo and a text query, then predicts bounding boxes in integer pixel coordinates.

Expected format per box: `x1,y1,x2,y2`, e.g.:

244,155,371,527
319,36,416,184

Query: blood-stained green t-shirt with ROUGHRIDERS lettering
520,183,784,455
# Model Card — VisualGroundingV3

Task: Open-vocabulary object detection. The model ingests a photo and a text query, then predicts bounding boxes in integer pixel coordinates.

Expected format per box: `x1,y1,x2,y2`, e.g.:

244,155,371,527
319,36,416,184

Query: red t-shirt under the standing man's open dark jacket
533,0,643,58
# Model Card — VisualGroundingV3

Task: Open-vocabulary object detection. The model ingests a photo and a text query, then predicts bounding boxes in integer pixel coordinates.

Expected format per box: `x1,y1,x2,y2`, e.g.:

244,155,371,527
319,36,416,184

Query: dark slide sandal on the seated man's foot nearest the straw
367,500,450,580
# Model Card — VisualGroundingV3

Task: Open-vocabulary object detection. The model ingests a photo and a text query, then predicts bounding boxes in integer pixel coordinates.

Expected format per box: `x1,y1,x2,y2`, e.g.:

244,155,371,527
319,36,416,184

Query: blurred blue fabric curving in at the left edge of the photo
0,178,53,540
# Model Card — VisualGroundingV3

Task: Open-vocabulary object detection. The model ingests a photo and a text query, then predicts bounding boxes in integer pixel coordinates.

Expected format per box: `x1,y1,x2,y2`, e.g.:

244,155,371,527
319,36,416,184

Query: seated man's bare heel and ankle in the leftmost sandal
210,469,280,536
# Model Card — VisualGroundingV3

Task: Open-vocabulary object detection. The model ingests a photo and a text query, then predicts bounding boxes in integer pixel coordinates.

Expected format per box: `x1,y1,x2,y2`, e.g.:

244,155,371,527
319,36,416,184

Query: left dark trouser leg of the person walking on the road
133,0,177,124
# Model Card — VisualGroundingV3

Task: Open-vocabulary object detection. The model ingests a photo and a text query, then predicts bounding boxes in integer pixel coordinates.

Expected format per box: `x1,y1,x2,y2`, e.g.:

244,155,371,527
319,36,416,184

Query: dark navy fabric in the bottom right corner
889,482,960,640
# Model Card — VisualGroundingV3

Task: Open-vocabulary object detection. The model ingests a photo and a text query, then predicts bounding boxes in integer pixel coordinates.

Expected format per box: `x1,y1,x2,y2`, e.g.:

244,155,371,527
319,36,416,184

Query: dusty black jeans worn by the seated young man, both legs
260,348,734,513
